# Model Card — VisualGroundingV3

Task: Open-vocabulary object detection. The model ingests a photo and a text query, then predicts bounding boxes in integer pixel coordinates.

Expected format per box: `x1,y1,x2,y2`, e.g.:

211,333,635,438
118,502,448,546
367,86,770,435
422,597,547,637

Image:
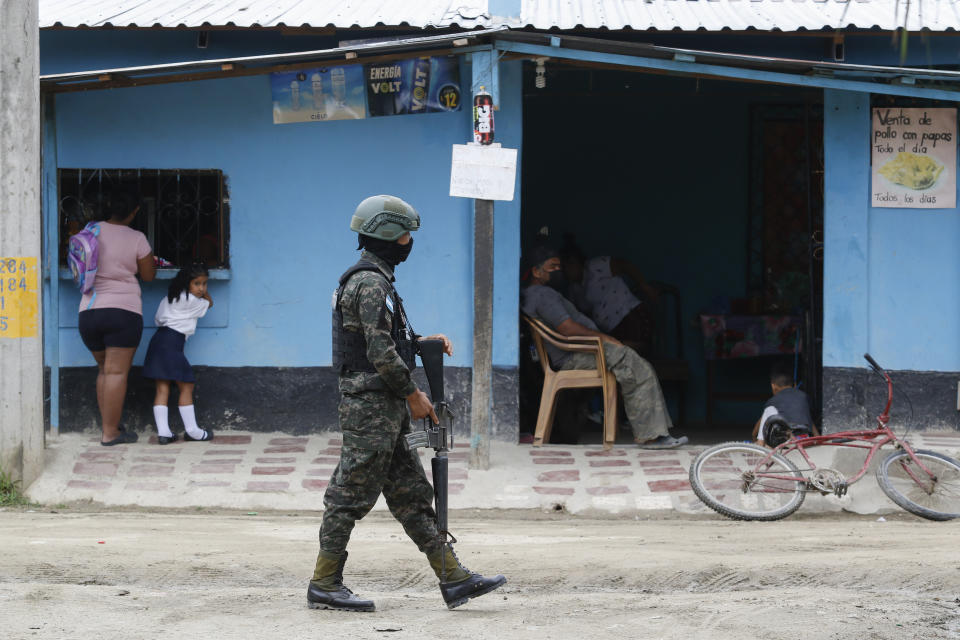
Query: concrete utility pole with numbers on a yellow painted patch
0,0,44,488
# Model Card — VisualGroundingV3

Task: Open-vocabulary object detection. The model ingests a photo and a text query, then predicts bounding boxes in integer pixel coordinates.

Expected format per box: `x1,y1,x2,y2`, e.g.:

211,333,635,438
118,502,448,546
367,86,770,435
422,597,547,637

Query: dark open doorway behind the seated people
520,63,823,444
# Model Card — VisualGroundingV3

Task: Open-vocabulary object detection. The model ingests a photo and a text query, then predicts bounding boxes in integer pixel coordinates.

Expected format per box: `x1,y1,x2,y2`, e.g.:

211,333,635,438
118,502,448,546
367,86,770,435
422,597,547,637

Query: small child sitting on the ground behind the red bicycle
753,362,820,447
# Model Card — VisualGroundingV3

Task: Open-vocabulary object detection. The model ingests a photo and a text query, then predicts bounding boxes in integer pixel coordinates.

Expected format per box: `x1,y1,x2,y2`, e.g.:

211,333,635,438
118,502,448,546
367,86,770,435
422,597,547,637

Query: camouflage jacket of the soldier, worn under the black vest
340,251,417,398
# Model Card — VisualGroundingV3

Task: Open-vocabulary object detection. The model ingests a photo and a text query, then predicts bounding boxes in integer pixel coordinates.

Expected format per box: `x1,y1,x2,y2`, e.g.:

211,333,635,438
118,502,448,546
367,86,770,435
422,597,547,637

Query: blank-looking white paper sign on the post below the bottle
450,143,517,200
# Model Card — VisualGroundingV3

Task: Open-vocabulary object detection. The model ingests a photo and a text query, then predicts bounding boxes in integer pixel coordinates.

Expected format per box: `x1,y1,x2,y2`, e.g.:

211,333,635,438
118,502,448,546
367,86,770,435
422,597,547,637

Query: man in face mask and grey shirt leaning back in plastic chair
521,246,687,449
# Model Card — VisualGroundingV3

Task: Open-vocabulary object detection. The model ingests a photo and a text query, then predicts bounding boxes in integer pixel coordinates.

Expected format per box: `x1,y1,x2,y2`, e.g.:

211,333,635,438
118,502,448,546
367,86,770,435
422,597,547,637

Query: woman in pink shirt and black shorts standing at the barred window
79,189,157,447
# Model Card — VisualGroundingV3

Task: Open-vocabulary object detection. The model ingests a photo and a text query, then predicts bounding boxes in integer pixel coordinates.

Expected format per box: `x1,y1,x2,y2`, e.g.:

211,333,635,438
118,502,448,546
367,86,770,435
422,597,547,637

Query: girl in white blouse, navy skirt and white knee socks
143,264,213,444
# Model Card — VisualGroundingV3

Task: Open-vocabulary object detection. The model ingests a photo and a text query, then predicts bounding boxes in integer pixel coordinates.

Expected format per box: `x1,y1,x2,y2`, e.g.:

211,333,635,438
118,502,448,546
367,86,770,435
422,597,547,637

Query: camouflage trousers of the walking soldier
320,391,440,555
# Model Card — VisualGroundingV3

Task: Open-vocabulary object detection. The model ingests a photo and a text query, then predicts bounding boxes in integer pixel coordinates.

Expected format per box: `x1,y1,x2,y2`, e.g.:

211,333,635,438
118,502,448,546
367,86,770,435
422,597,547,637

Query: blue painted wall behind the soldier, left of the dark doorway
41,32,522,366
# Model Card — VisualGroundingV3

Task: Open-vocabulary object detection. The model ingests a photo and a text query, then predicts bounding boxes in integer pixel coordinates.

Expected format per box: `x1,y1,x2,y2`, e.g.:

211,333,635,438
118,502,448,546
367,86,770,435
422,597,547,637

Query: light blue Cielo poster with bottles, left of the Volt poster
270,65,367,124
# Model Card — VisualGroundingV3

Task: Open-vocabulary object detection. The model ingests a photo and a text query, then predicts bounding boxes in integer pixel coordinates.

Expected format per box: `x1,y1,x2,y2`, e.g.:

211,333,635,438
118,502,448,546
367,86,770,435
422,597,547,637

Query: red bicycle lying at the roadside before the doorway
690,354,960,520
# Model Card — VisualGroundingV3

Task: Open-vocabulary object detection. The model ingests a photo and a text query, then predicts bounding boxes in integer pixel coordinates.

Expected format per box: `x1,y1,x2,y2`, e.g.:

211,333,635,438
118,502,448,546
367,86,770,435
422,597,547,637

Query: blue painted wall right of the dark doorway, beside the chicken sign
823,91,960,371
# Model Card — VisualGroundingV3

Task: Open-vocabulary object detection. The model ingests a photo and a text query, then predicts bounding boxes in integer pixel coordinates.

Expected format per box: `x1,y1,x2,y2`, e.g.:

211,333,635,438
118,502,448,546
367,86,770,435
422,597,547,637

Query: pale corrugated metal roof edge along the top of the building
40,0,960,31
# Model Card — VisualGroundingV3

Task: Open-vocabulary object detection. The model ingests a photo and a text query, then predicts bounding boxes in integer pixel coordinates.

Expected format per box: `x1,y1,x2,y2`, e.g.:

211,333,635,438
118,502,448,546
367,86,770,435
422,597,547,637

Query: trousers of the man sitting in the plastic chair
560,342,673,442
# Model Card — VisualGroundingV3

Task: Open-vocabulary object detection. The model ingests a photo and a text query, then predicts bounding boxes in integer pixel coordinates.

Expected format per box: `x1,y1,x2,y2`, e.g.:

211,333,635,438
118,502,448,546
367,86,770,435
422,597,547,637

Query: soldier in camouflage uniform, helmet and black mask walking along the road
307,196,506,611
